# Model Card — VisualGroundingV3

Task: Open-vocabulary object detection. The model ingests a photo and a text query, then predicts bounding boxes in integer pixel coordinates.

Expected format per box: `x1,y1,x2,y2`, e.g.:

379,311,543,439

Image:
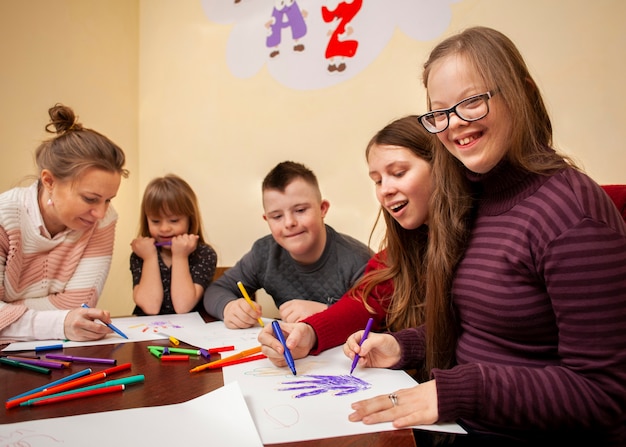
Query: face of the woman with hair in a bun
40,168,122,235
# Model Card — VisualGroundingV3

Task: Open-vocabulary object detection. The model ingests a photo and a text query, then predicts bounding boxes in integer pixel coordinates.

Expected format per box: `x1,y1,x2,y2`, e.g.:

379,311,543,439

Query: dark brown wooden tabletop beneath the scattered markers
0,340,415,447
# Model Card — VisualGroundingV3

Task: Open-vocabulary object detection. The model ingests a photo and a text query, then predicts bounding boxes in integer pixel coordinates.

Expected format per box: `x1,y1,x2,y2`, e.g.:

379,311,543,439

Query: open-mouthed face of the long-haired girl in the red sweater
367,144,432,230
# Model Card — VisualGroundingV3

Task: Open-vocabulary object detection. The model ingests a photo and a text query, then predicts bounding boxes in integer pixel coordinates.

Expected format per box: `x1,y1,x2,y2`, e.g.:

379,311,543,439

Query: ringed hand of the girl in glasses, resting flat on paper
348,380,439,428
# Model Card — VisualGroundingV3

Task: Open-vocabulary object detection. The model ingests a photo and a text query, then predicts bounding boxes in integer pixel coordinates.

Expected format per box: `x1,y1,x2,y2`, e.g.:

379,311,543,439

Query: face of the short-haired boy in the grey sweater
263,178,330,264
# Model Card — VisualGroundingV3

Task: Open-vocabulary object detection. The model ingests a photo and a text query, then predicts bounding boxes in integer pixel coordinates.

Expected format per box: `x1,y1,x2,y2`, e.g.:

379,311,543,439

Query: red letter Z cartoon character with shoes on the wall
322,0,363,73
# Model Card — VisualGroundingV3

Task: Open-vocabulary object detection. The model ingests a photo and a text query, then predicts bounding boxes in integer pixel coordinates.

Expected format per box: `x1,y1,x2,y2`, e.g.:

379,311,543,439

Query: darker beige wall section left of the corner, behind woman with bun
0,0,139,315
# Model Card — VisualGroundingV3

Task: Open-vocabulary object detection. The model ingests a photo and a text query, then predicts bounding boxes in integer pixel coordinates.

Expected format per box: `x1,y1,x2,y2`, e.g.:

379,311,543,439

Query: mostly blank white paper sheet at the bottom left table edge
0,382,263,447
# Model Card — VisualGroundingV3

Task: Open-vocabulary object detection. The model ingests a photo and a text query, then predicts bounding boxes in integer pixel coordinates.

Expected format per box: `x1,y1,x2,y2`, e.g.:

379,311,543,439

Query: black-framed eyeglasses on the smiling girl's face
417,90,497,133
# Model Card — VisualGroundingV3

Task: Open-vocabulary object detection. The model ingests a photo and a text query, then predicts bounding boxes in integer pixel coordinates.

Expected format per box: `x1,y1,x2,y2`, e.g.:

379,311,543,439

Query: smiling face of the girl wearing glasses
428,54,511,174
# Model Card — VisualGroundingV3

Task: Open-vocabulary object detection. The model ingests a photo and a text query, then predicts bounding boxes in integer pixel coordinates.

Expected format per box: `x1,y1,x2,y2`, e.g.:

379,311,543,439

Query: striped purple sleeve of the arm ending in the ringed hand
433,219,626,431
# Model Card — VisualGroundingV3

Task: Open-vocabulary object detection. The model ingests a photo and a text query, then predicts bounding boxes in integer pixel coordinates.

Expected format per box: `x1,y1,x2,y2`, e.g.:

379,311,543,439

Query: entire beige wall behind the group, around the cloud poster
0,0,626,315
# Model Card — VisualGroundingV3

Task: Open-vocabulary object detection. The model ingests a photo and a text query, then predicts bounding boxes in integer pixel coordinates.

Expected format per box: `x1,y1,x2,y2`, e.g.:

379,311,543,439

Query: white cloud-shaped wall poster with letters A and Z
201,0,458,90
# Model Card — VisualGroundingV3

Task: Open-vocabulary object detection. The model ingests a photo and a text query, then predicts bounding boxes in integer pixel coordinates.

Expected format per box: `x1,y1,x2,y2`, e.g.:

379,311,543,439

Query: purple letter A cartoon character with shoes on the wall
265,0,307,57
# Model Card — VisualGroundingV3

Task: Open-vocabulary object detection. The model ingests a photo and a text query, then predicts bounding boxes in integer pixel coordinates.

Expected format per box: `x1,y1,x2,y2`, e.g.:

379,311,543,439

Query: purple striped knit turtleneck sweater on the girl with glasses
394,166,626,446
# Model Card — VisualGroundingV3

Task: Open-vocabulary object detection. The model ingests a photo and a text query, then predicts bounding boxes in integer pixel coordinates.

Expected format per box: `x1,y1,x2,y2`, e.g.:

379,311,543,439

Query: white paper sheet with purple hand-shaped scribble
223,347,465,444
